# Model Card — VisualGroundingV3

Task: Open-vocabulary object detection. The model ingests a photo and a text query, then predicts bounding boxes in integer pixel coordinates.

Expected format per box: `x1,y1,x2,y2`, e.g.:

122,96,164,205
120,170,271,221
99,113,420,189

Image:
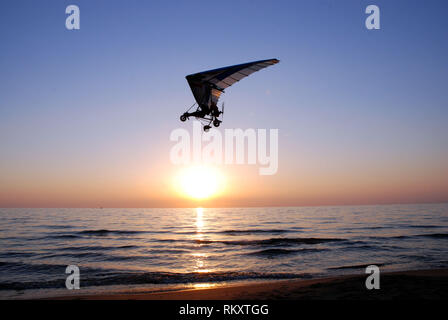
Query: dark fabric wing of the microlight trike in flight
186,59,279,106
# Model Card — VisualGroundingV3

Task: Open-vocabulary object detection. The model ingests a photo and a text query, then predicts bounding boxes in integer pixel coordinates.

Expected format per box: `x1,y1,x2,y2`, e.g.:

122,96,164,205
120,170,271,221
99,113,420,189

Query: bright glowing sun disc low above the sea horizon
176,165,224,200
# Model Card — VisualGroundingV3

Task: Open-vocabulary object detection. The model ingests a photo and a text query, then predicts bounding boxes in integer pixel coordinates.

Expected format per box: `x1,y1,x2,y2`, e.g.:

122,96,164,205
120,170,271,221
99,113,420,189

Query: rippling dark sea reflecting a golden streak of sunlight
0,204,448,299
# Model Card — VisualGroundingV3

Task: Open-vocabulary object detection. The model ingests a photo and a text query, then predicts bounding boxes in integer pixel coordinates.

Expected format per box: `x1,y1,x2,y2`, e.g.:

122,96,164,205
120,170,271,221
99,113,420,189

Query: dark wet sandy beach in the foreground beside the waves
49,269,448,300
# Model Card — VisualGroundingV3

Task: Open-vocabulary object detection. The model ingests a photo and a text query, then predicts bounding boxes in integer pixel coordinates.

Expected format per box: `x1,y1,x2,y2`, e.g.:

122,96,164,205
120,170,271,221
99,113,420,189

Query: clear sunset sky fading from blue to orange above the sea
0,0,448,207
